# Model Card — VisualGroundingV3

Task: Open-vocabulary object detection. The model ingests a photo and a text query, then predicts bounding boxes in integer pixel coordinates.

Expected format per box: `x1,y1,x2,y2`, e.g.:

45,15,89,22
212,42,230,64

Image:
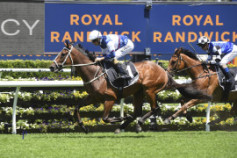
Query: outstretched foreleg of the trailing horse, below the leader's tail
164,99,203,124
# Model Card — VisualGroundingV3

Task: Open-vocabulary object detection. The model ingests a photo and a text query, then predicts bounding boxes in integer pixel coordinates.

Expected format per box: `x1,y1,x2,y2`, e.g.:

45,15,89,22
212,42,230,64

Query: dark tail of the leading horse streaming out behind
169,73,212,100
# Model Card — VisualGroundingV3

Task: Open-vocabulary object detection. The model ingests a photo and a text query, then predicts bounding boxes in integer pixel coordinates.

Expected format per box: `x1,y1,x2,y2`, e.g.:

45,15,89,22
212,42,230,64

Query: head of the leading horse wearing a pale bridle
49,42,73,72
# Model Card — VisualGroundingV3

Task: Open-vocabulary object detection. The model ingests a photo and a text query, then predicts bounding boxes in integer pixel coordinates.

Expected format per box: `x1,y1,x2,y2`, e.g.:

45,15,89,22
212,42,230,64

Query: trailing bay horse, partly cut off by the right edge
165,48,237,124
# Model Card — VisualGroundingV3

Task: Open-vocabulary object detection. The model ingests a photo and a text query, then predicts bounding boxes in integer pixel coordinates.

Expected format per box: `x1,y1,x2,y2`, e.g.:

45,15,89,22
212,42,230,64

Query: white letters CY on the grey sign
1,19,40,36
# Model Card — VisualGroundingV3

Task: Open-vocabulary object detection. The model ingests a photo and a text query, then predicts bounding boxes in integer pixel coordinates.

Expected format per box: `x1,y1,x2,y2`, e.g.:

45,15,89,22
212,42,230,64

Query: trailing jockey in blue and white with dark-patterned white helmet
197,36,237,83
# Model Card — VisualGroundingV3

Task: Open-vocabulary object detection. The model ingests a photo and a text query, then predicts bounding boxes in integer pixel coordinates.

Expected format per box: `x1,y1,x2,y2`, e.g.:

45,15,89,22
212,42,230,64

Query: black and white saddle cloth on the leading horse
104,61,139,89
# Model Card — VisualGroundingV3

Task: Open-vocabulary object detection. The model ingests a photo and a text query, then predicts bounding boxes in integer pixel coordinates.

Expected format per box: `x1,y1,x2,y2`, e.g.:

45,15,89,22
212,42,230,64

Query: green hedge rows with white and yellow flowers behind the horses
0,60,236,133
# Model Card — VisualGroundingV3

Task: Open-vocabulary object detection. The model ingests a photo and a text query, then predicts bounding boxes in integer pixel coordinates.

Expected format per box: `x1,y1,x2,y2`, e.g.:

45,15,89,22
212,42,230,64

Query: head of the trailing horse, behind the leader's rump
168,48,185,73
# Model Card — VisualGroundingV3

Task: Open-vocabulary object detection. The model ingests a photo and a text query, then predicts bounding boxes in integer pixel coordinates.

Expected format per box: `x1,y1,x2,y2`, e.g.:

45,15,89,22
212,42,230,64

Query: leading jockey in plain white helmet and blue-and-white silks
89,30,134,79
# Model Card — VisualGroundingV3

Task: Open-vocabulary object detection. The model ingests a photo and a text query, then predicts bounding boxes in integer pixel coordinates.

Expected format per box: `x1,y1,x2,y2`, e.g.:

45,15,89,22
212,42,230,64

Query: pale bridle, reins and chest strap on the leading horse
54,45,105,84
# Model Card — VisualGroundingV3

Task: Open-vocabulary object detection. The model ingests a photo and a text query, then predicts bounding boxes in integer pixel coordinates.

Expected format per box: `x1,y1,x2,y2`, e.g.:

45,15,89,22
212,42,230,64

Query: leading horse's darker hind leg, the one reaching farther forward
115,90,144,134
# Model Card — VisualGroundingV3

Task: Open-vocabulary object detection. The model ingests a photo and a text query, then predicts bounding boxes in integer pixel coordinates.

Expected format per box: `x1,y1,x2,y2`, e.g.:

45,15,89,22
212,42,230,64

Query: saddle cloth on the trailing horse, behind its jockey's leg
216,66,237,90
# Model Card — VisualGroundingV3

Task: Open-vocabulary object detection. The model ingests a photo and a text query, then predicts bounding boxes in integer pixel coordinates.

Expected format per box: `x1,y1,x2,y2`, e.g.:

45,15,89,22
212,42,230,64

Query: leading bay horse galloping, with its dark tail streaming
50,42,209,133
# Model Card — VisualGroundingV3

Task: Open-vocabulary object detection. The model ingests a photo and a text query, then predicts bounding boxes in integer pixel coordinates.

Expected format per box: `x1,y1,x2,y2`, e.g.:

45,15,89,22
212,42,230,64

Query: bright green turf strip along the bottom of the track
0,131,237,158
